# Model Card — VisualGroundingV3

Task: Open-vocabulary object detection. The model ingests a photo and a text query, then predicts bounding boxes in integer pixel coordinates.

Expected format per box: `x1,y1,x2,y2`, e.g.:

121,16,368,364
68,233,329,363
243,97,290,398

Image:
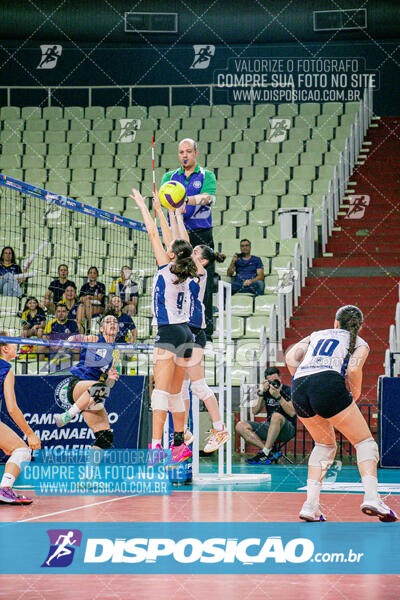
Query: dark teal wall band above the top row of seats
0,40,400,115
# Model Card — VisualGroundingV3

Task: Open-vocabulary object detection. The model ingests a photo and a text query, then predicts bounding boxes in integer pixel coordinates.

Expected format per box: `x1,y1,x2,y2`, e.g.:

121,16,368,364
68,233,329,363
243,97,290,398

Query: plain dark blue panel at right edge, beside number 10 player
379,377,400,468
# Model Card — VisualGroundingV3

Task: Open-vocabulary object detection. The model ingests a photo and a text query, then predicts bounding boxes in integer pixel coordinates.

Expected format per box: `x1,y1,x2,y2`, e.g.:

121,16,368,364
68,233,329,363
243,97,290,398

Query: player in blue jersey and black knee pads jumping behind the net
54,311,119,450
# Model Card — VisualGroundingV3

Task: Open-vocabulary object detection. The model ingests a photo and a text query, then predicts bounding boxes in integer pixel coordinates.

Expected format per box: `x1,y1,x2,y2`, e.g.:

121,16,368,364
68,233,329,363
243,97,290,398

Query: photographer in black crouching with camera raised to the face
236,367,297,465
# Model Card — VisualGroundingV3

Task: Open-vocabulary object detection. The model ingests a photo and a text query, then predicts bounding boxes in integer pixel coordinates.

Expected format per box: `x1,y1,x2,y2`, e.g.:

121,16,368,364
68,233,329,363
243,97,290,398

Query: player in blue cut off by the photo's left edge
0,331,41,505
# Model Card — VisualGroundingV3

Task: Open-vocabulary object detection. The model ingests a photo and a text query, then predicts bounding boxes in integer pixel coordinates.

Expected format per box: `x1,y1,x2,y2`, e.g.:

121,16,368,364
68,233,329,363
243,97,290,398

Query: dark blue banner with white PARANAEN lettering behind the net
0,375,145,462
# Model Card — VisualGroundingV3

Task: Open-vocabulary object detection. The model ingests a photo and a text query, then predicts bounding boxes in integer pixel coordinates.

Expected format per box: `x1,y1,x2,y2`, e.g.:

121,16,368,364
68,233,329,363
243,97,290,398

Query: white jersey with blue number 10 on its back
293,329,369,379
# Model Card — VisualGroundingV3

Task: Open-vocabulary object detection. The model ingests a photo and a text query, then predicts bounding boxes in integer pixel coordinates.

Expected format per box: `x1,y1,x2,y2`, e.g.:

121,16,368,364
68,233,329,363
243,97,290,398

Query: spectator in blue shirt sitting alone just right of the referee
226,239,265,296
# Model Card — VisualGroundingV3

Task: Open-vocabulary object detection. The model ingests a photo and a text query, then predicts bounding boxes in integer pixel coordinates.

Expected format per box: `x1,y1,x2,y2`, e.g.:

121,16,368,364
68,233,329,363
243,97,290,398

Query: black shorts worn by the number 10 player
292,371,353,419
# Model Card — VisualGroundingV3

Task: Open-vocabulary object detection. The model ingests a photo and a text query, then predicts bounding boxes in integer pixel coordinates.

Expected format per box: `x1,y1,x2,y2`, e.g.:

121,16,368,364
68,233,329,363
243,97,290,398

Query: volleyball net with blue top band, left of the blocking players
0,174,156,374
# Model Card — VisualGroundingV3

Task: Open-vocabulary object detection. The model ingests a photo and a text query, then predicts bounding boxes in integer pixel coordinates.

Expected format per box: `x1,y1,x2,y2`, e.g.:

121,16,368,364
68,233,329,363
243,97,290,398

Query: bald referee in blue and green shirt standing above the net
162,138,217,342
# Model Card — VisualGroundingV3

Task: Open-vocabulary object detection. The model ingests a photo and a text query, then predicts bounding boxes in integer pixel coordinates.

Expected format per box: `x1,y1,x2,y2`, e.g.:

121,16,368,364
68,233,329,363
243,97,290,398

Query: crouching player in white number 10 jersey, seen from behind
286,305,397,521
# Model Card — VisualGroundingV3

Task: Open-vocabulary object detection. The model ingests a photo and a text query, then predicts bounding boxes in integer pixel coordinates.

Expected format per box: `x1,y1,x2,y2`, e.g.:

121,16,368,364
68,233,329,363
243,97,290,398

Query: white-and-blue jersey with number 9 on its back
152,263,190,325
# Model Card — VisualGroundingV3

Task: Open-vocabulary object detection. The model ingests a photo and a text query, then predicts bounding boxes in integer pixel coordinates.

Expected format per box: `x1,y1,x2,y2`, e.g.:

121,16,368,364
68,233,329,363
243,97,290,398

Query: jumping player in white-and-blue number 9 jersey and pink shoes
131,189,197,463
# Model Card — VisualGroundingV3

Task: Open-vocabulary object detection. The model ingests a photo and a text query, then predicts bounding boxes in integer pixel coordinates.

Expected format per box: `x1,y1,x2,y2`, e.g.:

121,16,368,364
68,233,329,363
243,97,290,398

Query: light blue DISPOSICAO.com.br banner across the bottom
0,520,400,575
